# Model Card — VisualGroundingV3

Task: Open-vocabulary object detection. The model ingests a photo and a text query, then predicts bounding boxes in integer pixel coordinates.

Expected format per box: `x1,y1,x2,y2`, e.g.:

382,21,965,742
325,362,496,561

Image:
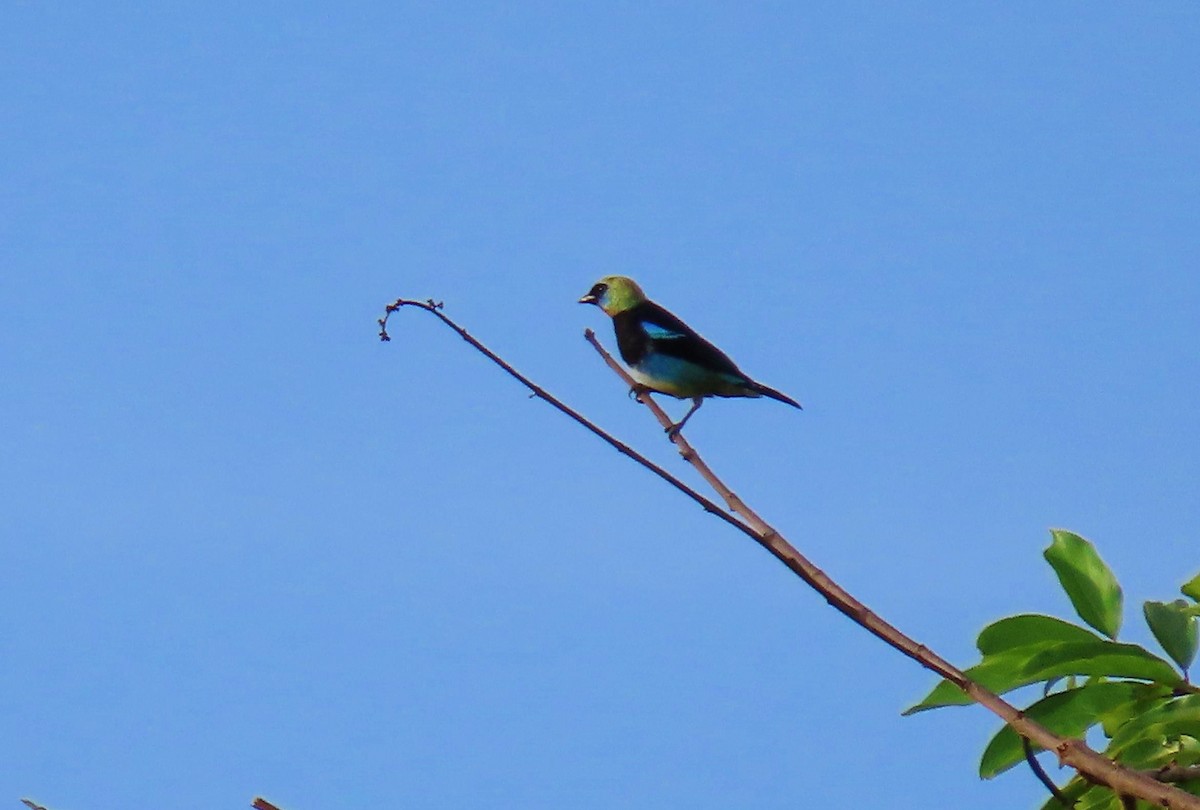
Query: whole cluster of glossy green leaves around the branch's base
905,530,1200,810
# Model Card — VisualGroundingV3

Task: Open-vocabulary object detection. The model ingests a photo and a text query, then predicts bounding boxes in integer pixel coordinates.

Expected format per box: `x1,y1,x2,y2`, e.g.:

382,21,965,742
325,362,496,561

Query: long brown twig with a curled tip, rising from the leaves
379,299,1200,810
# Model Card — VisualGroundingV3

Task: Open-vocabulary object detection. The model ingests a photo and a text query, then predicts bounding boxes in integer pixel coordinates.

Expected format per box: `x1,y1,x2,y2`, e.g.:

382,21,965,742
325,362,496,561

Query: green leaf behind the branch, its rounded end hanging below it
979,680,1140,779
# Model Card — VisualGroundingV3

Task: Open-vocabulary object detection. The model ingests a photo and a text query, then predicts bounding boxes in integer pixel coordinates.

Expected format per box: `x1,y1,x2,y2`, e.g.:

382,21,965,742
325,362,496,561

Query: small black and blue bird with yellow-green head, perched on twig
580,276,800,437
